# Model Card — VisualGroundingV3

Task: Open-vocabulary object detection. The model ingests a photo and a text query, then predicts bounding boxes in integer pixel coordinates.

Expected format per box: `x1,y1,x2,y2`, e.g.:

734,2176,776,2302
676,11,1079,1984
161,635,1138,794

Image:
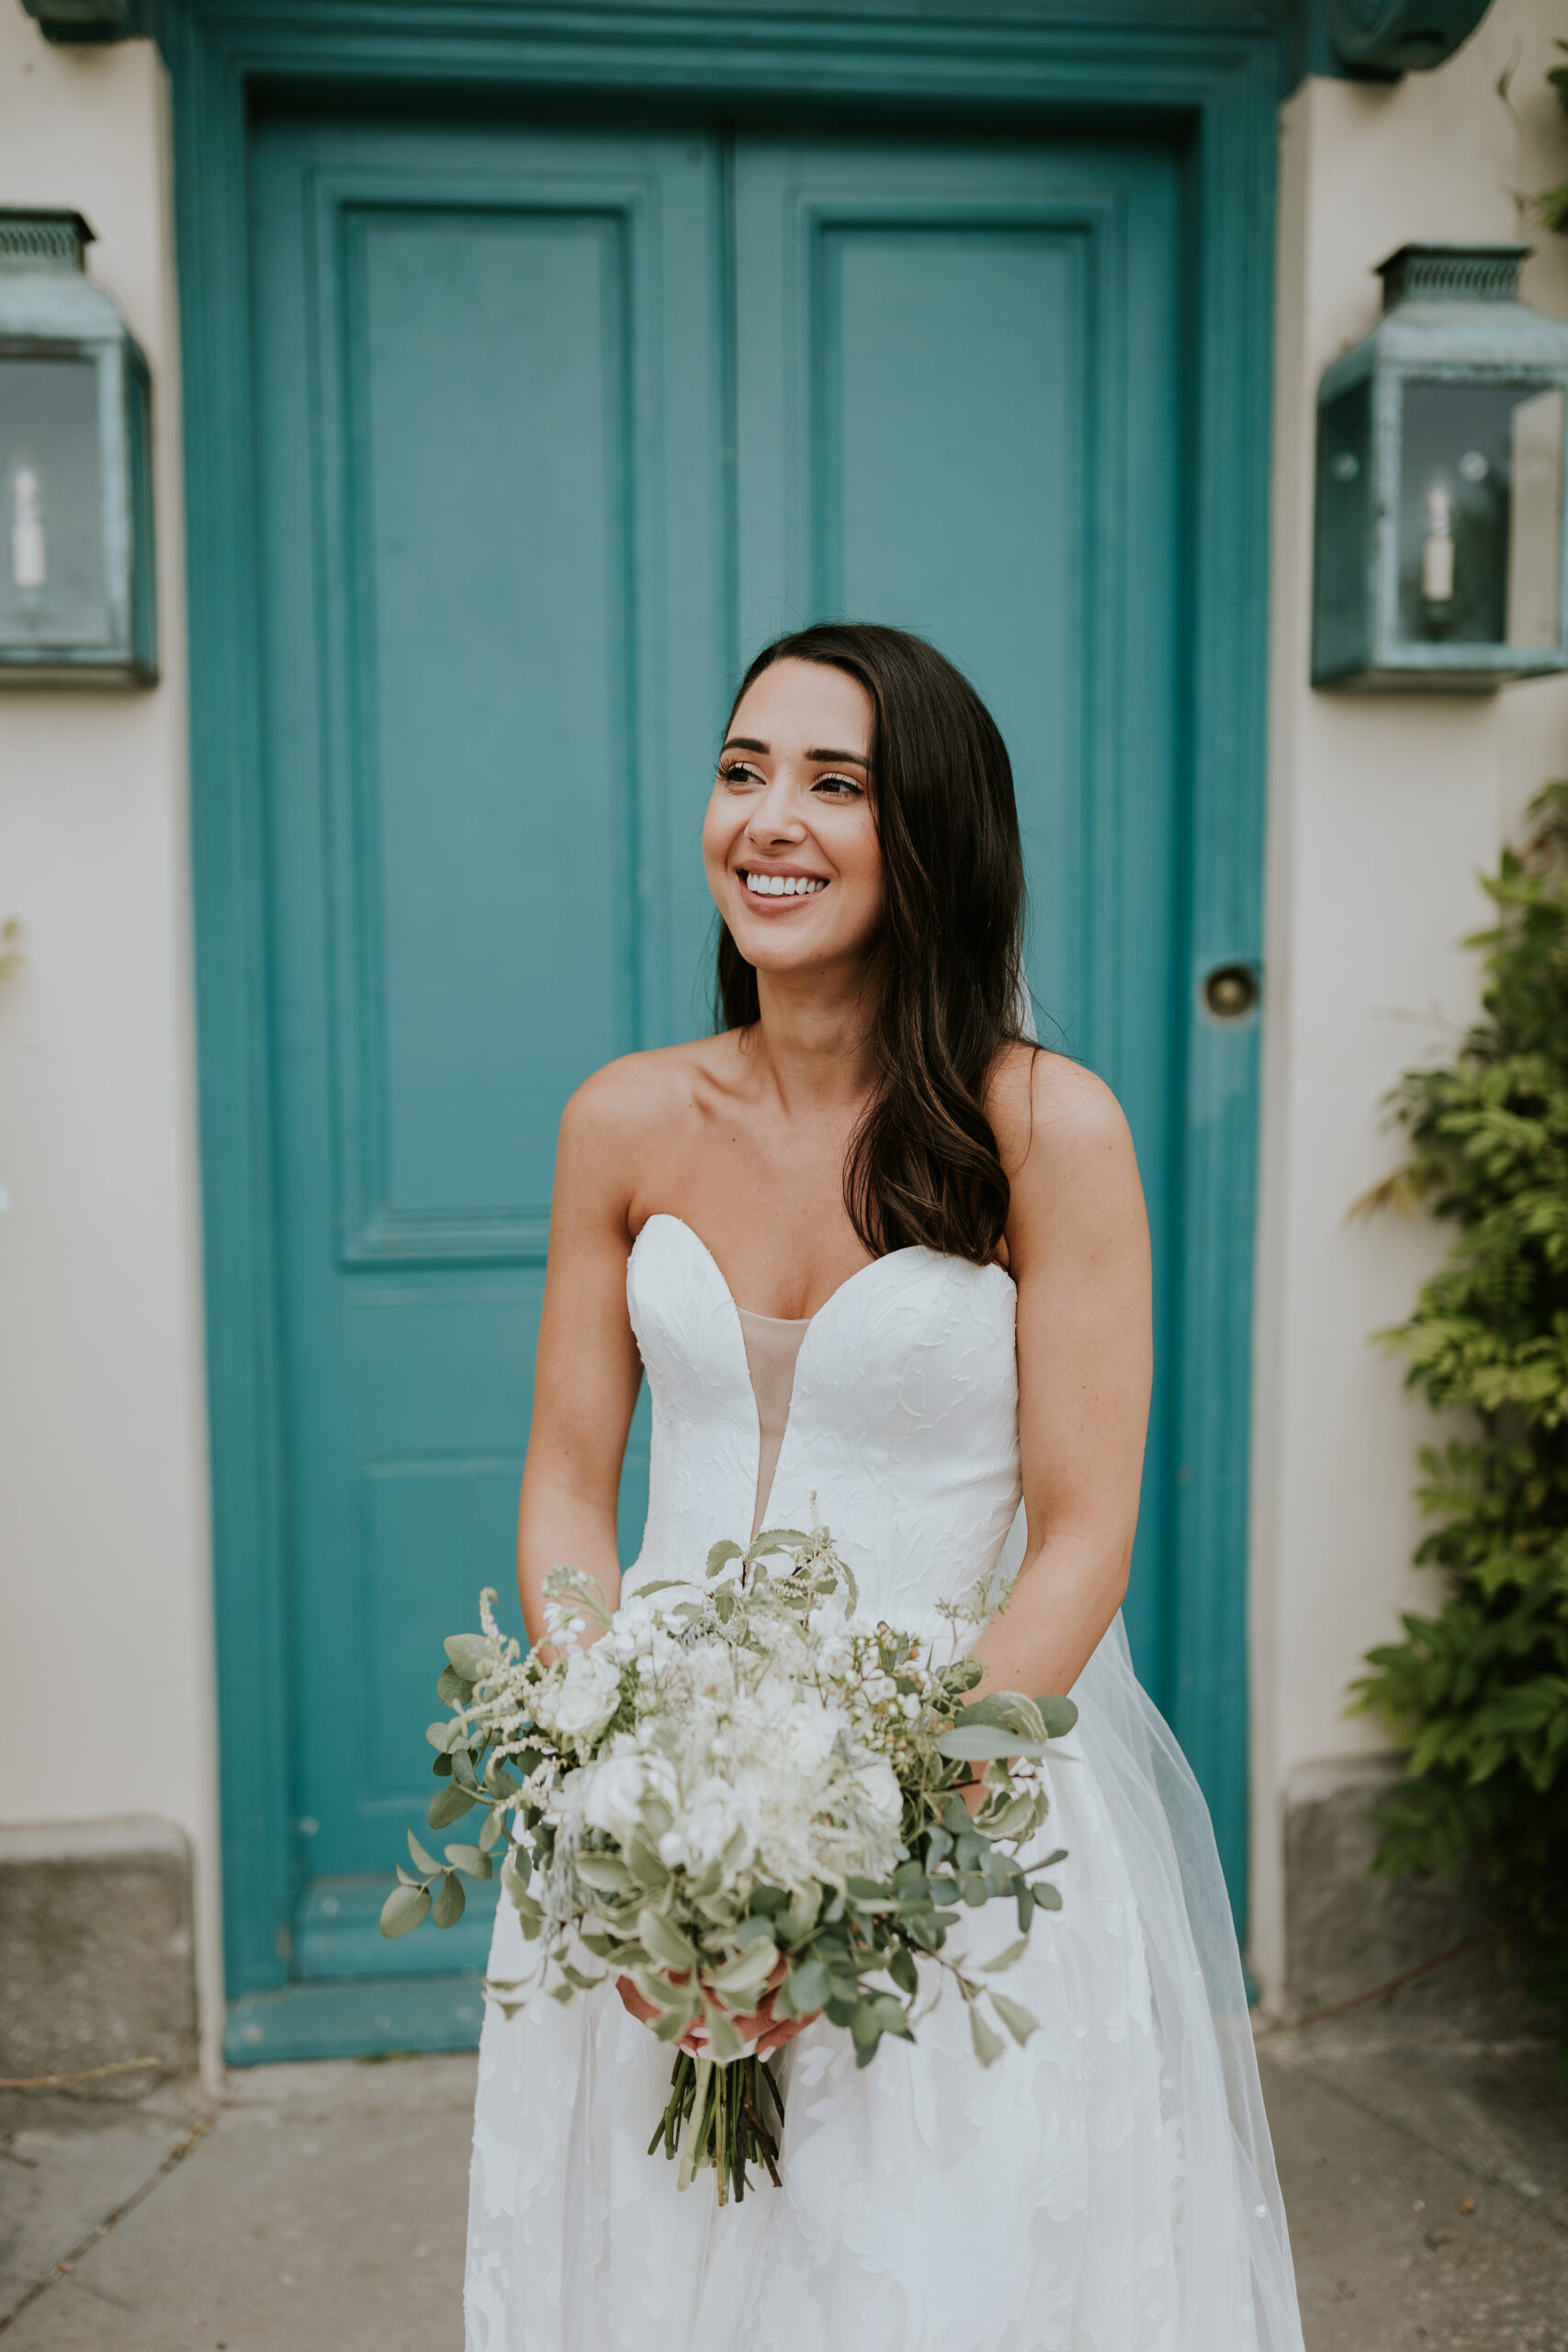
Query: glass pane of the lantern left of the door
0,353,108,647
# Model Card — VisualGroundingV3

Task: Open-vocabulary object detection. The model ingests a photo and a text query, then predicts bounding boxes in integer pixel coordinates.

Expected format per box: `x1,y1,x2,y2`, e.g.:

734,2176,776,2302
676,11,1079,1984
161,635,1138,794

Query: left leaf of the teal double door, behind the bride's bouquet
254,125,722,1978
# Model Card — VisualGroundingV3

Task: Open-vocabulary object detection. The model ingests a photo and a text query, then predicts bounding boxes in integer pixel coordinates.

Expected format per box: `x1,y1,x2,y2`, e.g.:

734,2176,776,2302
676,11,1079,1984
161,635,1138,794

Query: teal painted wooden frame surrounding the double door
157,0,1298,2063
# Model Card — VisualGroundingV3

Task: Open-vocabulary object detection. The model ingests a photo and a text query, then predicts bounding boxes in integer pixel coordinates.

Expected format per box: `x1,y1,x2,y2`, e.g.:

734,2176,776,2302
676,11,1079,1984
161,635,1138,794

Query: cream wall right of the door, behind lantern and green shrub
1251,0,1568,1992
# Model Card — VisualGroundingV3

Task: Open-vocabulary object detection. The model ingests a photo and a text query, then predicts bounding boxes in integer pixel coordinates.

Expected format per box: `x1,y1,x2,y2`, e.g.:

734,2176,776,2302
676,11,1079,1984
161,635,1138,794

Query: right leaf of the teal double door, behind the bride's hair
736,139,1185,1719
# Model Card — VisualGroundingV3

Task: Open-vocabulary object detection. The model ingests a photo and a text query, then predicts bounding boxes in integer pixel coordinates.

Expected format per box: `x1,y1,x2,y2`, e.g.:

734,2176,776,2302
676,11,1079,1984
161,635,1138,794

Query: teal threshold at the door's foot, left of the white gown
223,1971,484,2065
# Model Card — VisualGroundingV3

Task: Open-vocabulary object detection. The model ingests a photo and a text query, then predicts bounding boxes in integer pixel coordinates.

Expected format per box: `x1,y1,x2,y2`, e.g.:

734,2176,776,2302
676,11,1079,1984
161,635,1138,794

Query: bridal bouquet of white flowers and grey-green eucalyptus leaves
381,1526,1077,2204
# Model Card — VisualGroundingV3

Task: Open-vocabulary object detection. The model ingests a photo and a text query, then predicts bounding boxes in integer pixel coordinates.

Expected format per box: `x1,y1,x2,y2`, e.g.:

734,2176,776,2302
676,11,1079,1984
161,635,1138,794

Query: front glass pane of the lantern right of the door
1399,379,1563,644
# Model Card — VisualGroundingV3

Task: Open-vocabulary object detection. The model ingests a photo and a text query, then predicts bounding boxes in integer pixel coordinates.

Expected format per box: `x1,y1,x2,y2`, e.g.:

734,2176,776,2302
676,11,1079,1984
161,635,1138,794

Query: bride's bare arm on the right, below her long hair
976,1051,1152,1698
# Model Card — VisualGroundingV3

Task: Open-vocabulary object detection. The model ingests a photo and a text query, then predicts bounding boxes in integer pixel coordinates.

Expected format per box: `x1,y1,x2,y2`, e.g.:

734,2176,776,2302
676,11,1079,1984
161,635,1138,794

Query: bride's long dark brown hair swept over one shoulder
715,621,1025,1265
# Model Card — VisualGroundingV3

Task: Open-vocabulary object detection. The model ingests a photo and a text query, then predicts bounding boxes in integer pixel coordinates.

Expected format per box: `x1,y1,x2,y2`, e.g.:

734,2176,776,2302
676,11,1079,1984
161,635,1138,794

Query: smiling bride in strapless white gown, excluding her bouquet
466,626,1300,2352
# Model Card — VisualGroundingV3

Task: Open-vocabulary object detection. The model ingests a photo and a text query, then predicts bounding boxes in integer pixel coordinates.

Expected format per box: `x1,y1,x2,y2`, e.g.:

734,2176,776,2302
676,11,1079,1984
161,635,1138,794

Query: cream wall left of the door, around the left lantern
0,14,221,2055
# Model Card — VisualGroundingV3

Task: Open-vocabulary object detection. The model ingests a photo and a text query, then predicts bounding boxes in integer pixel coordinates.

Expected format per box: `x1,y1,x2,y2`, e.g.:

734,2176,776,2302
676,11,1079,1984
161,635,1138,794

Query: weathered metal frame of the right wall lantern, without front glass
1312,244,1568,694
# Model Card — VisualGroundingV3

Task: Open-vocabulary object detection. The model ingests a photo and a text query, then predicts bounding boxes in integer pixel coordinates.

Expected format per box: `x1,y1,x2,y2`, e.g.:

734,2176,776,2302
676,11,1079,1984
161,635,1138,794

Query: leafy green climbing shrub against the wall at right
1357,780,1568,2031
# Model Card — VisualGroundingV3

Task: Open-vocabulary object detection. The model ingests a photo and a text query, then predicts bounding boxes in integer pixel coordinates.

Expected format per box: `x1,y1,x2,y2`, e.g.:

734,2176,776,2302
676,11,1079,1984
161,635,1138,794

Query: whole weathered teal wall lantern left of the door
0,211,157,684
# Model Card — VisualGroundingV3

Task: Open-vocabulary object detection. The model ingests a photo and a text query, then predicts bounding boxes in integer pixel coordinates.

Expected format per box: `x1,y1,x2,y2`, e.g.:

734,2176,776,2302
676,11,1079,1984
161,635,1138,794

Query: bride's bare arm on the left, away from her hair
517,1063,642,1642
